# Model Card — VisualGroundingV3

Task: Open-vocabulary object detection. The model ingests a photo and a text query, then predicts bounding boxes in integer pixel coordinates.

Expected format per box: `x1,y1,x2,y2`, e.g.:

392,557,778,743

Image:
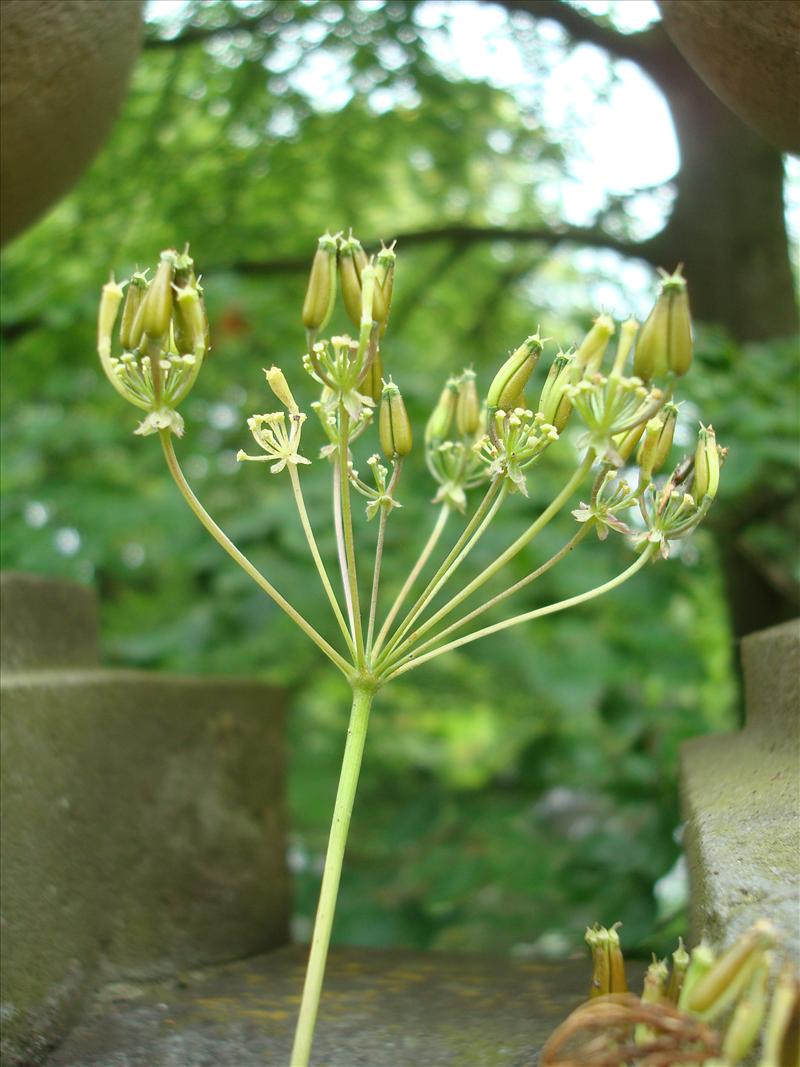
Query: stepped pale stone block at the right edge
682,620,800,964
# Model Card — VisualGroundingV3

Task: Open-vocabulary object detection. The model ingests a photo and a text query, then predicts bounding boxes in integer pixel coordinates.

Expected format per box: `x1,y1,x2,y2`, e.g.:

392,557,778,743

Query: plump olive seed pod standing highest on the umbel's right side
634,267,692,382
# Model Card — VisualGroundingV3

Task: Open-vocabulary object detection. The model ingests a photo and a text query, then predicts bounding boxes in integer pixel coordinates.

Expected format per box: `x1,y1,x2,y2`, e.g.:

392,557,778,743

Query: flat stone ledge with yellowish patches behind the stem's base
48,947,590,1067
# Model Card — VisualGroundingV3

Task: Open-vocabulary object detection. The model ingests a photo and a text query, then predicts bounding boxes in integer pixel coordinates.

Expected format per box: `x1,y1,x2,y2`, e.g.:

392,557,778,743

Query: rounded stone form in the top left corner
0,0,142,242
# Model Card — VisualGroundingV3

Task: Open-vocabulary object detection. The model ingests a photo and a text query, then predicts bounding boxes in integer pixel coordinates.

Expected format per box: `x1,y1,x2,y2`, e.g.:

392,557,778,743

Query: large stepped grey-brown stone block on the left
0,582,290,1065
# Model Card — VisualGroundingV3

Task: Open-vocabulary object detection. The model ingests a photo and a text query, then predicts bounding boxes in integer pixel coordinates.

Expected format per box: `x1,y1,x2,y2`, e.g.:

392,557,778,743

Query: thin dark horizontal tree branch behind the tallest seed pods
226,223,650,274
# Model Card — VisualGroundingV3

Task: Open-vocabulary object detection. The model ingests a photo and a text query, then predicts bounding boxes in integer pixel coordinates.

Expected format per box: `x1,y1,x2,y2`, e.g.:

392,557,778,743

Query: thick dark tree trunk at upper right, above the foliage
642,36,798,340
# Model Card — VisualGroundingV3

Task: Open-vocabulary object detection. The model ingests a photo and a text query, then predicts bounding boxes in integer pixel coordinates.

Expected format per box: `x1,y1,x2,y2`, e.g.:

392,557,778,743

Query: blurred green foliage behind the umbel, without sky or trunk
2,2,795,954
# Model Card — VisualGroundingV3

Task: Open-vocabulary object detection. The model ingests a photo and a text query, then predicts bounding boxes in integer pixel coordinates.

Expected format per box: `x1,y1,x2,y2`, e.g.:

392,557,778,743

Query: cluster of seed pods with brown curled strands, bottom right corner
539,921,800,1067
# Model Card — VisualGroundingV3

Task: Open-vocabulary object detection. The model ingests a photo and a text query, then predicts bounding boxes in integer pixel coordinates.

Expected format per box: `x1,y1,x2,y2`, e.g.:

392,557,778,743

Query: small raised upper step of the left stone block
0,571,99,671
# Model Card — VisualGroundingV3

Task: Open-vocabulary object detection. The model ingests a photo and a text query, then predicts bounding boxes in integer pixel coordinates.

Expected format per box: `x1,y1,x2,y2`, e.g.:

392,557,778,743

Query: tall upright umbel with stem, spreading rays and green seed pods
98,233,725,1067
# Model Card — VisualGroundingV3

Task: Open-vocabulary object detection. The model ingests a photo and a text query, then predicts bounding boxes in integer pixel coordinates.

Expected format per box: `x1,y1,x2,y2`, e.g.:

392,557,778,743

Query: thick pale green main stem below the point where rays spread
290,686,373,1067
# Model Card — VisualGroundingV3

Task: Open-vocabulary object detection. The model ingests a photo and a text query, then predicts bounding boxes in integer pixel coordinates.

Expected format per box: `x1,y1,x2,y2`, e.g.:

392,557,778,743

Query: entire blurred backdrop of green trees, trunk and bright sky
2,0,798,956
